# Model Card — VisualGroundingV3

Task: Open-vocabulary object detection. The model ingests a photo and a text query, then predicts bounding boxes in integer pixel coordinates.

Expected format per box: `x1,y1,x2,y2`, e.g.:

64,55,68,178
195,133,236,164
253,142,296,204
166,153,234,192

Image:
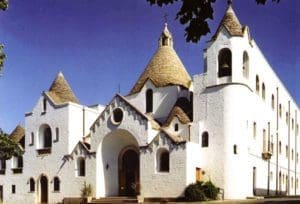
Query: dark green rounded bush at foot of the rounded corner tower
184,181,219,201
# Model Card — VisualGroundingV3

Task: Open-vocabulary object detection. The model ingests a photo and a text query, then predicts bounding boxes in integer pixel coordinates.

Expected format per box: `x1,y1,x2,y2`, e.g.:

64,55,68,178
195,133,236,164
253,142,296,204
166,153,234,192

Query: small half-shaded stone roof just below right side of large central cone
164,97,193,126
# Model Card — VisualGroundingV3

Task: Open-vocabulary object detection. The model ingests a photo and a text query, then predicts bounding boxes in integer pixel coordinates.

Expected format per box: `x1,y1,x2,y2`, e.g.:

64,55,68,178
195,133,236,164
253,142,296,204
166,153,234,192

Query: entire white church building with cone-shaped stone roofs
0,4,300,204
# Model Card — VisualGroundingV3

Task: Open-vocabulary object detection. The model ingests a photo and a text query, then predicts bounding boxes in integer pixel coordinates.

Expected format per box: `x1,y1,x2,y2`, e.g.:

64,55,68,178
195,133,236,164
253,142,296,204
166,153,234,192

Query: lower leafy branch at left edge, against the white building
0,132,23,160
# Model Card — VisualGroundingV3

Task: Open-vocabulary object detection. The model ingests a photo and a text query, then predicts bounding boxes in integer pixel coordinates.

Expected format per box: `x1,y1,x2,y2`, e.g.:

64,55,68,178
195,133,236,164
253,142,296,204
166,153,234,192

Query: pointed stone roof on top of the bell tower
212,4,244,39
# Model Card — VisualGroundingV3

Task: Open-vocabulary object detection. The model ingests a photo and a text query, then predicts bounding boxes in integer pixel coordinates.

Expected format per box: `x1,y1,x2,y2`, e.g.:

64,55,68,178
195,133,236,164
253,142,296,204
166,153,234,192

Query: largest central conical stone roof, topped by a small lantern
130,25,192,94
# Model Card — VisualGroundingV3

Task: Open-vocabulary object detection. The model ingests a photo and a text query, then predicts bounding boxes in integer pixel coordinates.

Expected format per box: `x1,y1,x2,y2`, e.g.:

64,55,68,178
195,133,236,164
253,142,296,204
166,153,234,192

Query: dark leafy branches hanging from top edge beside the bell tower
146,0,280,43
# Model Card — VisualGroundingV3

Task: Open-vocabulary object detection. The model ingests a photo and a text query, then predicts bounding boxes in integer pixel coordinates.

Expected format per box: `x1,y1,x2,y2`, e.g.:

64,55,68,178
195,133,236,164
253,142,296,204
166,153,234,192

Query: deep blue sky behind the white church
0,0,300,132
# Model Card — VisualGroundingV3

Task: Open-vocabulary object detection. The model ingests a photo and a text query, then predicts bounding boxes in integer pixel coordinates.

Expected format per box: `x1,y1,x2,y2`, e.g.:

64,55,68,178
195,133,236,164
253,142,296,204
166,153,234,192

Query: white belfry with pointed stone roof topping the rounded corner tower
204,0,251,86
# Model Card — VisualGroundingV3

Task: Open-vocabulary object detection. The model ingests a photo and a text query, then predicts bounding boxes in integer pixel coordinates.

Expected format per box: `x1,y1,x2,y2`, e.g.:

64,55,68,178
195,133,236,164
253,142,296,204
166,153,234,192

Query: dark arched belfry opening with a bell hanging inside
218,48,232,77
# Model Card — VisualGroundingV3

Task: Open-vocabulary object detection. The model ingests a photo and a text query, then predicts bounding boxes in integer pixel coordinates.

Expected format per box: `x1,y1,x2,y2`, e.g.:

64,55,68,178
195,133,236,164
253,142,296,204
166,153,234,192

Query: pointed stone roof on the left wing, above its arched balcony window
46,72,79,104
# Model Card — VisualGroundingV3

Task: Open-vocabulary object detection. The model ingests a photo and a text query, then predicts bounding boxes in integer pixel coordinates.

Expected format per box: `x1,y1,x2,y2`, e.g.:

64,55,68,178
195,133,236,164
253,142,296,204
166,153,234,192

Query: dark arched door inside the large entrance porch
119,149,140,196
